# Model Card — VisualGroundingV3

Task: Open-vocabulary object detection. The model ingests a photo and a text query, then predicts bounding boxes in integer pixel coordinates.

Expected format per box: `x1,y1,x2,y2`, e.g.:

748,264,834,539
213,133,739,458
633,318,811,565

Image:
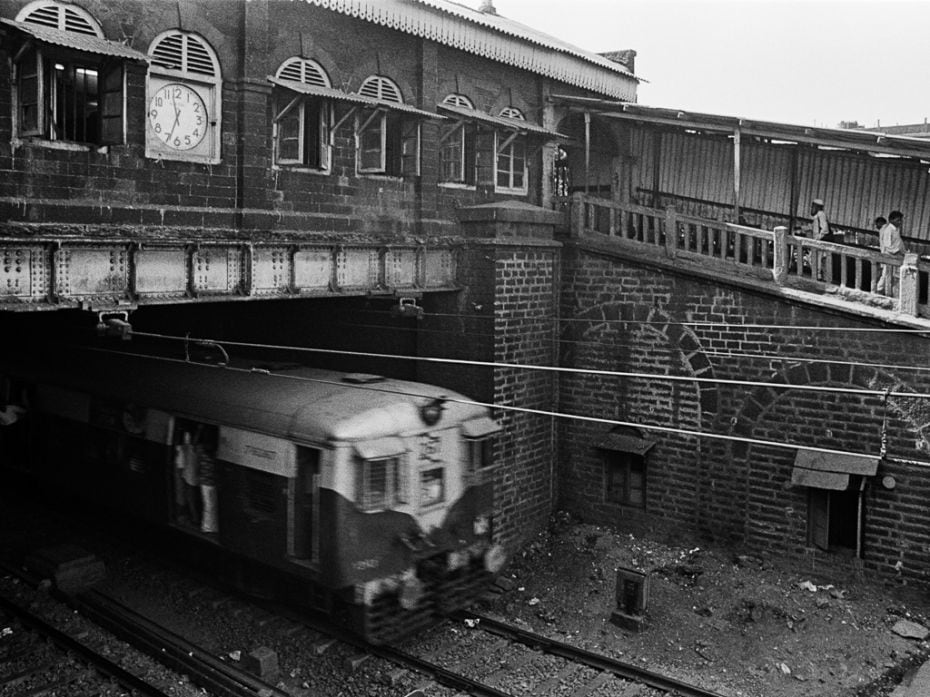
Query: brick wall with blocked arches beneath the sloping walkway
559,248,930,584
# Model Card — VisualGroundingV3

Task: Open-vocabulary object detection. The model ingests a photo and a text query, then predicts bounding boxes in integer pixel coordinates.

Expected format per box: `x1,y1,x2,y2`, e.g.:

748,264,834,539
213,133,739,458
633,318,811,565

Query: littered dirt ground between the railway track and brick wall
484,514,930,697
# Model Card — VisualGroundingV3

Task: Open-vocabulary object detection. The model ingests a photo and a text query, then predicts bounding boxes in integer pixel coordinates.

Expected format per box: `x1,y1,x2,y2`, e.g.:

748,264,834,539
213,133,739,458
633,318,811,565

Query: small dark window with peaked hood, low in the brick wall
597,426,655,508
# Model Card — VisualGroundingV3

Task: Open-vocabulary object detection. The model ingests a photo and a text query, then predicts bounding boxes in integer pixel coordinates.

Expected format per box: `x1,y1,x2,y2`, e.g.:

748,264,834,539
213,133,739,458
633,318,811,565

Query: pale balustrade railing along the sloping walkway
571,194,930,317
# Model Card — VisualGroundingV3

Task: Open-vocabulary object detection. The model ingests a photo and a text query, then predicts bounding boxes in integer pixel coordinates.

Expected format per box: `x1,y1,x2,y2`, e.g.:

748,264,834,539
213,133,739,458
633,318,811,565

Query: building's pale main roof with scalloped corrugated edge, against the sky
305,0,640,100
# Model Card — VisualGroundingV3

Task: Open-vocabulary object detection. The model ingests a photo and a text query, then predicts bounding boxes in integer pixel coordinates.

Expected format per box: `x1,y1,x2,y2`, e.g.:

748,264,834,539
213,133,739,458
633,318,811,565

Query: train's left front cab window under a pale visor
355,438,408,511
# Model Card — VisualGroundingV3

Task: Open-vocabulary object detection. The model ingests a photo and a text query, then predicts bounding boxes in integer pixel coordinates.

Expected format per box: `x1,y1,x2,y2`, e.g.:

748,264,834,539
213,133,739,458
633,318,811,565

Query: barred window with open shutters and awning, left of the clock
0,1,147,145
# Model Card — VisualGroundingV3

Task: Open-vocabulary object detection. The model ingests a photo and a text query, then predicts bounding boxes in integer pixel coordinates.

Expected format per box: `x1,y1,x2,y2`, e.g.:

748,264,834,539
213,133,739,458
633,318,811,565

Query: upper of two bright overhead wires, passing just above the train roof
133,331,930,399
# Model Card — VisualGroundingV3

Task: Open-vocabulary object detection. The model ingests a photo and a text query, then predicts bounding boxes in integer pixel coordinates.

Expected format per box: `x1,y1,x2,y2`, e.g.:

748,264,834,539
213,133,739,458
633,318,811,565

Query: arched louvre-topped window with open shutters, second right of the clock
355,75,420,176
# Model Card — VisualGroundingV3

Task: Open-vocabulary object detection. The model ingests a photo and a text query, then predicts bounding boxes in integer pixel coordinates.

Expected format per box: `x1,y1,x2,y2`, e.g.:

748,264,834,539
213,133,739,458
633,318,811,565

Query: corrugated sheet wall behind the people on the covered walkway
630,127,930,241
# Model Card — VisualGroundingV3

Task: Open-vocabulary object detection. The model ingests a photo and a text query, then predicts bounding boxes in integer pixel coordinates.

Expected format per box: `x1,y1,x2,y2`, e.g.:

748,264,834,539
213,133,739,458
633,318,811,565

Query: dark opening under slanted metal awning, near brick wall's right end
791,450,878,557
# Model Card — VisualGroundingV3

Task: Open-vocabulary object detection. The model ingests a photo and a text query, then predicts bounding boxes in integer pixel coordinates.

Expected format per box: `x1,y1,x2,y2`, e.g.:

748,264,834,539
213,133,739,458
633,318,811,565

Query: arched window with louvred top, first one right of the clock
274,57,333,171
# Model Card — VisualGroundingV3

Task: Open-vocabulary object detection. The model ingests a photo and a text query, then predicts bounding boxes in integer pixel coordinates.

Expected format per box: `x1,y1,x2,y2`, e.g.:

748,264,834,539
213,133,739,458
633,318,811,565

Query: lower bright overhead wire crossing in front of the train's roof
81,349,930,468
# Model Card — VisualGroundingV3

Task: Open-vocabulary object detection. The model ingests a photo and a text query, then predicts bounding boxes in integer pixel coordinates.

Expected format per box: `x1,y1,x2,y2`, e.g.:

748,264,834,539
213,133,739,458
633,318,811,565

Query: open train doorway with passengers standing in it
174,424,219,533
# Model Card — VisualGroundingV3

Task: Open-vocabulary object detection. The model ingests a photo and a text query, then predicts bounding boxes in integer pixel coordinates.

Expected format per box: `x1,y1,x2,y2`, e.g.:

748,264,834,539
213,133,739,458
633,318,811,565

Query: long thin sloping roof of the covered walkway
552,94,930,159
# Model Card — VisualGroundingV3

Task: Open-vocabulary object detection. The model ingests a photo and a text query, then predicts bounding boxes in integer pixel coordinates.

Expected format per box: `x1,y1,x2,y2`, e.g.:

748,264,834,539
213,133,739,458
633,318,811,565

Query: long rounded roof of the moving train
4,350,488,442
